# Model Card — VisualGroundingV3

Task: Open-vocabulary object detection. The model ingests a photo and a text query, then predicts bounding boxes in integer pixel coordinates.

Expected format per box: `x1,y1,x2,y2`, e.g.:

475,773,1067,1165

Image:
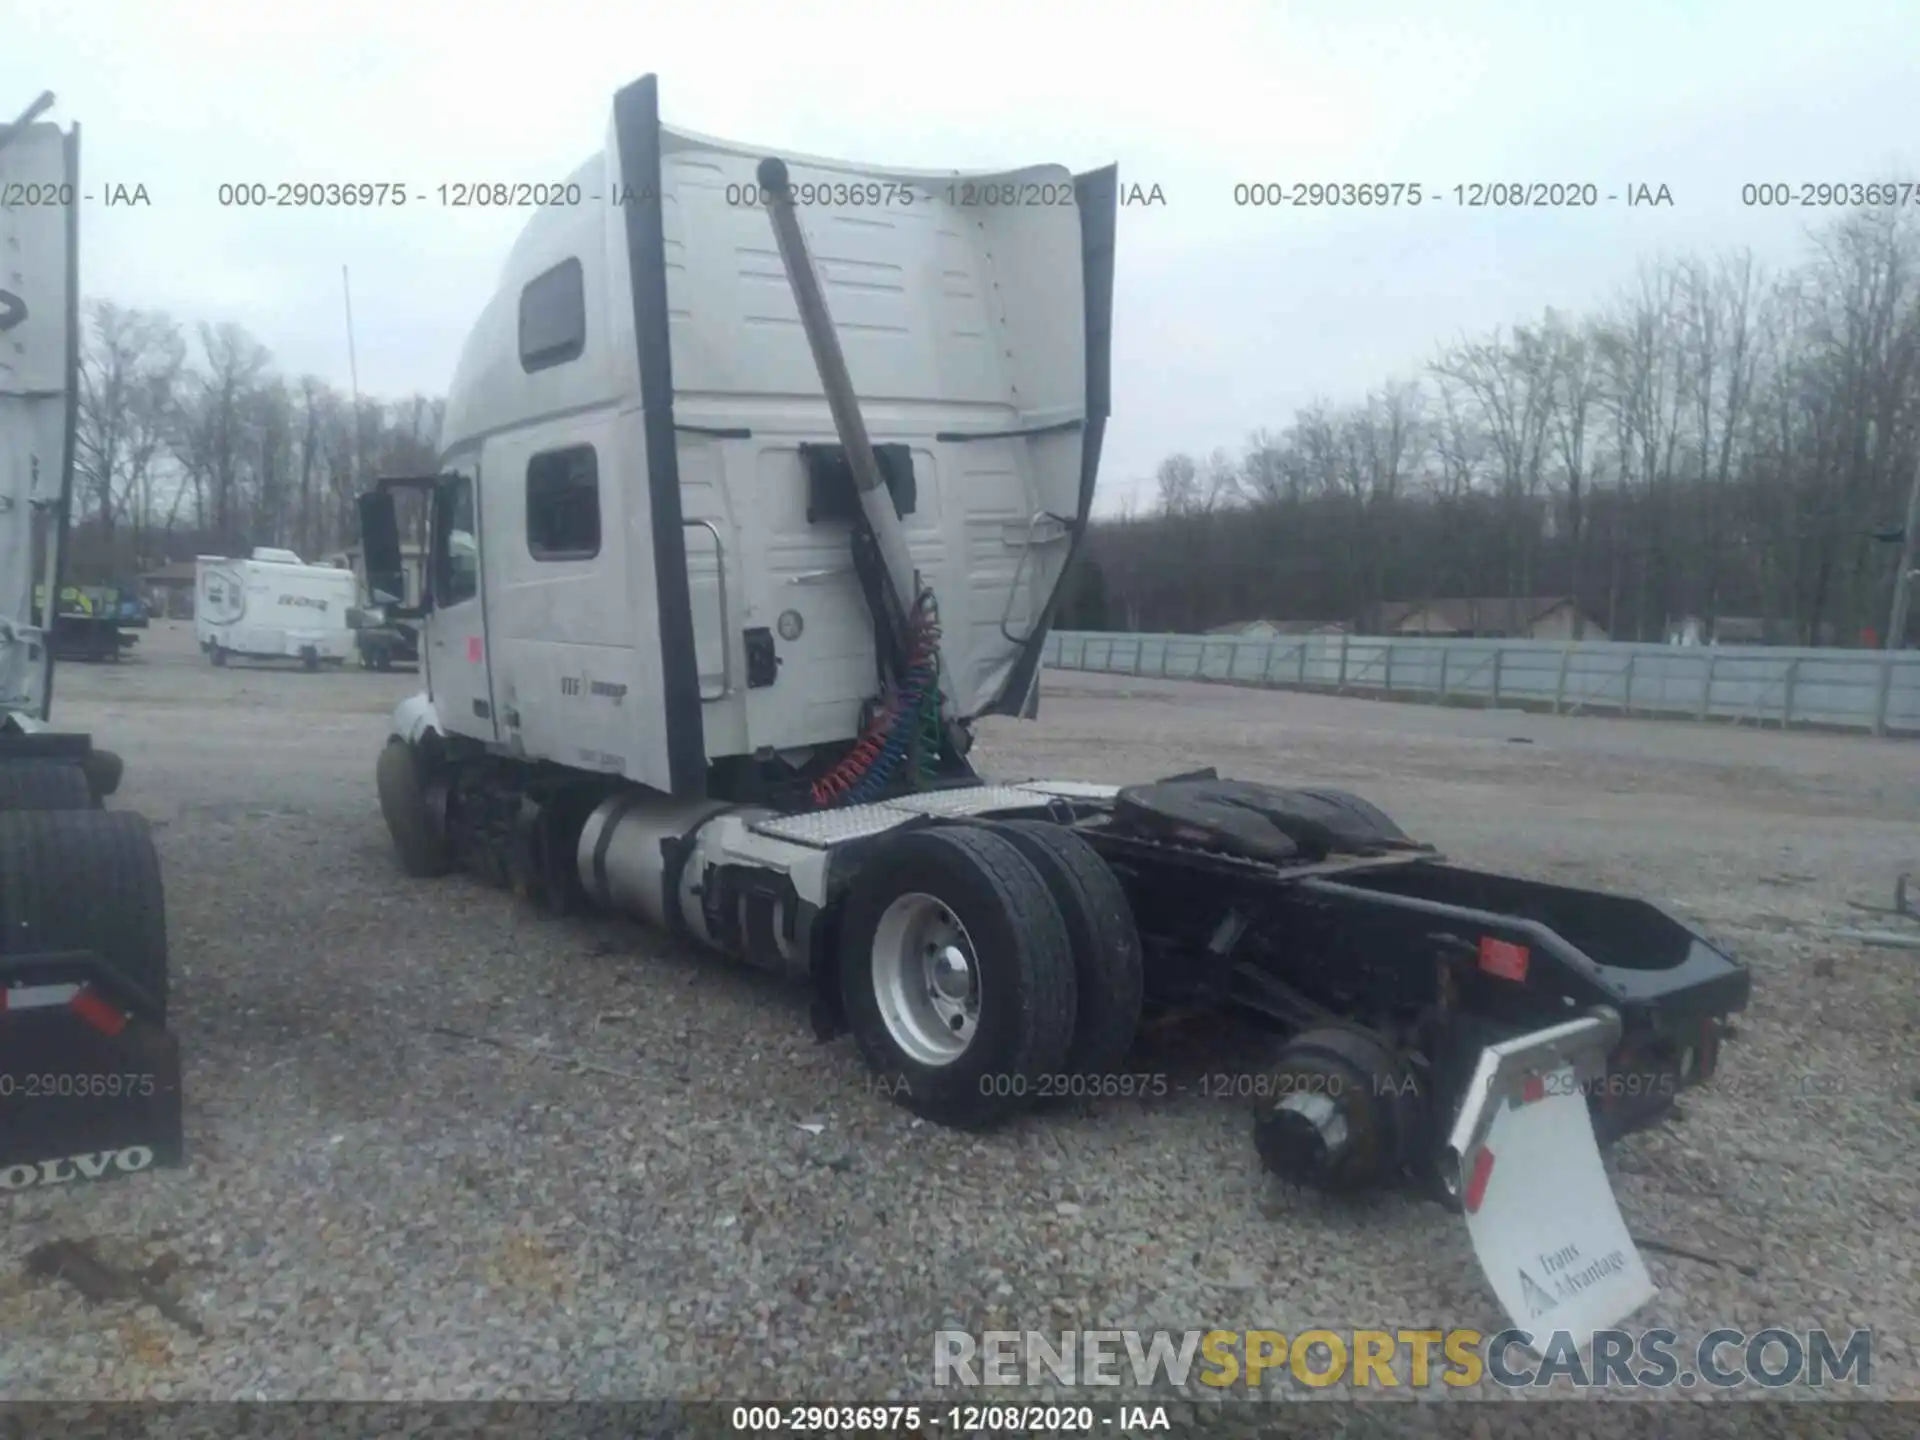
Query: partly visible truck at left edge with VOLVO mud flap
0,94,180,1196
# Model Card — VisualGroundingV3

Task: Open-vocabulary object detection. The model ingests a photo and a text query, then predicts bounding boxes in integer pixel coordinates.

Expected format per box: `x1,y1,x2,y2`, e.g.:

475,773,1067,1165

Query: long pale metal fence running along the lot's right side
1046,630,1920,735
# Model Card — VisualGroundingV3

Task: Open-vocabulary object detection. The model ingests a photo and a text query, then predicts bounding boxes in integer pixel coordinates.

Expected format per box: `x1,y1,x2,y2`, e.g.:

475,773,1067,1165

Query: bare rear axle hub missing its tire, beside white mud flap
1254,1025,1430,1194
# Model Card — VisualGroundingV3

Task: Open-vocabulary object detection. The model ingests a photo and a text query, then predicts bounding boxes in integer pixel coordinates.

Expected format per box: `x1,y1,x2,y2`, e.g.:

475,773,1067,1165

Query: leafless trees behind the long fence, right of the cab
1060,207,1920,643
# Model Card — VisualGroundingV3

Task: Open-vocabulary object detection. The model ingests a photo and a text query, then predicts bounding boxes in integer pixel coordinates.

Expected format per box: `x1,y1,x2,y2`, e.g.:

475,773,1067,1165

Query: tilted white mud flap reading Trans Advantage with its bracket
1442,1012,1653,1354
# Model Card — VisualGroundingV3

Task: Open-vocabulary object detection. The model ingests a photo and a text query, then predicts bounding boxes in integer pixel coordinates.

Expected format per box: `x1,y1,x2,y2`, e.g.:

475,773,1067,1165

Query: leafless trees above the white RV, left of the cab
67,300,445,584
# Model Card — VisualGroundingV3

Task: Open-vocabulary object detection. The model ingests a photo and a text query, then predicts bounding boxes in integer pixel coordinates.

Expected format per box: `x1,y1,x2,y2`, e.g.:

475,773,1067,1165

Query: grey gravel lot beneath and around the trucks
0,624,1920,1402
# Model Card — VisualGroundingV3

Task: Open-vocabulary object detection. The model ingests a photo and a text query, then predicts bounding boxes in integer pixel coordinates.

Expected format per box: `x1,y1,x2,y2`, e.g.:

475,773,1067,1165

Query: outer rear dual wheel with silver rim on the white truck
839,826,1075,1125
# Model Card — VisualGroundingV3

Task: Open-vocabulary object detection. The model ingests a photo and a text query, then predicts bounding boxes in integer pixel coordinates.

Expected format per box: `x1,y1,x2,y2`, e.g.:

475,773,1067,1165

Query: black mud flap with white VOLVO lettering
0,954,184,1196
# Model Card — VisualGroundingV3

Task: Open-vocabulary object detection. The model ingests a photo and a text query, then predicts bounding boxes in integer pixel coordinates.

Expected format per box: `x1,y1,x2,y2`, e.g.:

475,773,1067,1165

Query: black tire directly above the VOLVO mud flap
0,810,167,1023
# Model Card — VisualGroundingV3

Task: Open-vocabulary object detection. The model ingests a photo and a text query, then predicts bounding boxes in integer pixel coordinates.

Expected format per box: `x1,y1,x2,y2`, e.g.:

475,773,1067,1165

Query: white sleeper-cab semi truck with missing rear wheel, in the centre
361,77,1749,1329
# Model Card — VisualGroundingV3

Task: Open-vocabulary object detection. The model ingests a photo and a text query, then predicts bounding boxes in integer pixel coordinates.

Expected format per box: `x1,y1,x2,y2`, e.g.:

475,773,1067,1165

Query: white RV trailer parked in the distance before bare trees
194,545,357,670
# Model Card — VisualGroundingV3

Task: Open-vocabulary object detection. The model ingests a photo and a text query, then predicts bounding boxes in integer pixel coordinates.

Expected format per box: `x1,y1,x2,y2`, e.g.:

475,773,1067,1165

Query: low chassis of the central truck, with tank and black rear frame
390,737,1749,1190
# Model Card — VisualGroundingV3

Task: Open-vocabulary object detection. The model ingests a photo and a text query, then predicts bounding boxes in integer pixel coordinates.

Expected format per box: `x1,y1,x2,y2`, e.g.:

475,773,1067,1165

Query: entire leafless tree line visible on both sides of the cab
69,207,1920,643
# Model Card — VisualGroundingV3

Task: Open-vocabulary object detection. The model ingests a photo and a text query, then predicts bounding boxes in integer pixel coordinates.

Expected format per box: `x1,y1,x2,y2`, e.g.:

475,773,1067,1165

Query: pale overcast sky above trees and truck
15,0,1920,511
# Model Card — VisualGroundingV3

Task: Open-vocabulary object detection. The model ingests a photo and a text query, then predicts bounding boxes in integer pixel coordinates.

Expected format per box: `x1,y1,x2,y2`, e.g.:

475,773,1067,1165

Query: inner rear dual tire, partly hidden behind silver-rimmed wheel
993,820,1146,1077
